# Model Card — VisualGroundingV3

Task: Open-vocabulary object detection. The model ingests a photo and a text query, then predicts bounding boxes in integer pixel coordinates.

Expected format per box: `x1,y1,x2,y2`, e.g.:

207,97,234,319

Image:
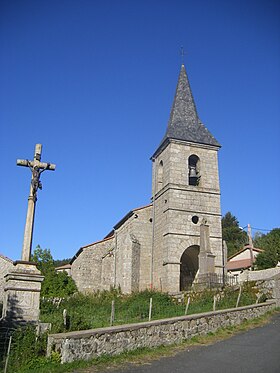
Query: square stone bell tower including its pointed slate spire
151,65,222,293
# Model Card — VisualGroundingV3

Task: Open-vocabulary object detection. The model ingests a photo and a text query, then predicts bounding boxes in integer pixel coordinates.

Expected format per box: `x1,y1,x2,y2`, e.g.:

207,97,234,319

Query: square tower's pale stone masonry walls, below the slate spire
153,141,222,292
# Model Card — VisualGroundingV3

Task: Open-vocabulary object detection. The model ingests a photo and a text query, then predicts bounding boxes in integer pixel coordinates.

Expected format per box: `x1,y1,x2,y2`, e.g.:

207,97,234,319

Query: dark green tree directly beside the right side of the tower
222,212,248,257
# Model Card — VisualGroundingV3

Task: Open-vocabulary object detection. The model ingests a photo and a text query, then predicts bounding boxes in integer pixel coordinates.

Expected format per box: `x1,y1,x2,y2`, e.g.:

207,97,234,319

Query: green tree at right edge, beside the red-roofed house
254,228,280,269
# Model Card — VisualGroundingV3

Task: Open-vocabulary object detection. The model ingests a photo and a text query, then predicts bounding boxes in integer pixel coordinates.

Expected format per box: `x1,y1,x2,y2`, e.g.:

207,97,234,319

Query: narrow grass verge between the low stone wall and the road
12,310,279,373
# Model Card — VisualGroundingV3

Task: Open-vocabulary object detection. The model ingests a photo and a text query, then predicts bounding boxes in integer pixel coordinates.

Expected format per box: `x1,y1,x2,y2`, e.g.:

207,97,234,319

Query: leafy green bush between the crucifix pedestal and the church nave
31,246,77,298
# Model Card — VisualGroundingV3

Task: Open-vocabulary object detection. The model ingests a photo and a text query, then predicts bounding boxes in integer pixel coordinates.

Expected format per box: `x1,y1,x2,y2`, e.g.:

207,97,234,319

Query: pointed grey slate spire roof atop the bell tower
154,65,221,156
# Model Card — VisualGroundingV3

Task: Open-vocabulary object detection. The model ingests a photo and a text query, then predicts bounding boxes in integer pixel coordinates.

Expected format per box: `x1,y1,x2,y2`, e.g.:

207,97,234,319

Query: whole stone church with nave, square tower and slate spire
70,65,223,293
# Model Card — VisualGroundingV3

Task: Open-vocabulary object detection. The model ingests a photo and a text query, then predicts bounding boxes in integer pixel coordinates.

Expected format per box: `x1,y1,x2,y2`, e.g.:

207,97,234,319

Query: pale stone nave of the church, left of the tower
71,205,152,293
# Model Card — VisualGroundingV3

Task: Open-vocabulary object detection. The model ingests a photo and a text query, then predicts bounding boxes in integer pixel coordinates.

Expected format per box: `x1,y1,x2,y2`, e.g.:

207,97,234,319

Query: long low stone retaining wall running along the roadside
48,301,275,363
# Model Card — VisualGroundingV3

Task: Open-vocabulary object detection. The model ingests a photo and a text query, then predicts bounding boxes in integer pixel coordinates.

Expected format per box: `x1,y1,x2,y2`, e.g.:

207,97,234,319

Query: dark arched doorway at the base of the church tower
180,245,199,291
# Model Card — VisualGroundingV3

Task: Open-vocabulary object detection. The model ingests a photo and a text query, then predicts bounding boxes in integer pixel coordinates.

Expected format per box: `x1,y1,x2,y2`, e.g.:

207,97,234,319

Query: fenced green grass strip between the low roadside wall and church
41,285,264,333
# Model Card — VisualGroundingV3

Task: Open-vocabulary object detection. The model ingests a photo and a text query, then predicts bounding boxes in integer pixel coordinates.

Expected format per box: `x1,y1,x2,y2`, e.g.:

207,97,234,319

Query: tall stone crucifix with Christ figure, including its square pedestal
2,144,55,323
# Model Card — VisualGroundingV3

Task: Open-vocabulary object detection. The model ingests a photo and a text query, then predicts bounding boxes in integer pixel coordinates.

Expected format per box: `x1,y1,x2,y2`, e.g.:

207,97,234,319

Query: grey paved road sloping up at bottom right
110,315,280,373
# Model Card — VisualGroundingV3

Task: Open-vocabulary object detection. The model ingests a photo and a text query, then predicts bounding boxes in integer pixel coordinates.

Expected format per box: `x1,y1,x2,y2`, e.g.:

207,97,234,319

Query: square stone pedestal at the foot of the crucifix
2,261,44,323
